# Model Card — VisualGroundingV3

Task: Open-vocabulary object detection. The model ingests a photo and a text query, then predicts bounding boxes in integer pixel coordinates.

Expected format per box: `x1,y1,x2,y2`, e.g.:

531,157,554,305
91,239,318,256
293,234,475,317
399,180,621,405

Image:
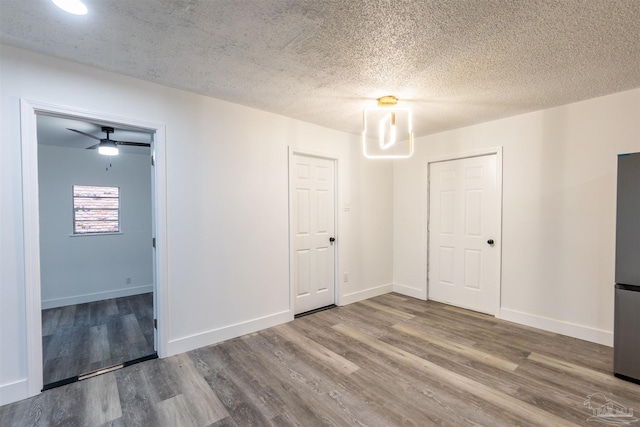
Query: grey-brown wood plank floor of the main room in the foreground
0,294,640,427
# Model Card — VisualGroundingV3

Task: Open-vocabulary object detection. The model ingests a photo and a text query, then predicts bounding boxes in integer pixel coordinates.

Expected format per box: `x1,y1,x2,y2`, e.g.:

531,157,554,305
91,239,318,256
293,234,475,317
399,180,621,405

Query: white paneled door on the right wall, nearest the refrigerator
429,154,500,315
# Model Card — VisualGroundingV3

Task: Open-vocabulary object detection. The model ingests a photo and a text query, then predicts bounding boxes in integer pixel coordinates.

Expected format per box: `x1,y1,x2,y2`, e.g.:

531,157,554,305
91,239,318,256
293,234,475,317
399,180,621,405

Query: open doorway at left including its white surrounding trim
21,99,167,396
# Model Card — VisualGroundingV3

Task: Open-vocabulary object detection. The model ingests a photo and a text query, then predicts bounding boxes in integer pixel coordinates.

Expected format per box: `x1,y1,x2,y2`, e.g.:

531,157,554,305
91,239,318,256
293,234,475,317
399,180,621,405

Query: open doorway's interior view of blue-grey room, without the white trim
36,114,157,390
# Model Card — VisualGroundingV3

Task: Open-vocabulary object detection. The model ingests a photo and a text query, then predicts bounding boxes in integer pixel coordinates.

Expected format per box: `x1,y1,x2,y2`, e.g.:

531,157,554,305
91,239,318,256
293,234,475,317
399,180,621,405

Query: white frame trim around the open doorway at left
20,98,168,397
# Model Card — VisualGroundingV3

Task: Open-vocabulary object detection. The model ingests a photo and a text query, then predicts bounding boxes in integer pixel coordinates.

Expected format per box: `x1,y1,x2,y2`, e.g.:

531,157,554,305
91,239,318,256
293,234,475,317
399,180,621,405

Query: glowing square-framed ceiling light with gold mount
362,96,413,159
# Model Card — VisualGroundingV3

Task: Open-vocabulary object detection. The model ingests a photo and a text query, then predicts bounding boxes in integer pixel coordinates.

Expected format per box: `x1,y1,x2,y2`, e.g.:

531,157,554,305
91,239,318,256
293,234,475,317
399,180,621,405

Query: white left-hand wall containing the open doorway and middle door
0,46,393,404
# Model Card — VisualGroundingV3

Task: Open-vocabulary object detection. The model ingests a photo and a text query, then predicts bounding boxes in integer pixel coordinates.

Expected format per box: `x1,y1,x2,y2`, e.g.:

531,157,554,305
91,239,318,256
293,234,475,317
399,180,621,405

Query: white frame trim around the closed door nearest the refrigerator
423,146,502,316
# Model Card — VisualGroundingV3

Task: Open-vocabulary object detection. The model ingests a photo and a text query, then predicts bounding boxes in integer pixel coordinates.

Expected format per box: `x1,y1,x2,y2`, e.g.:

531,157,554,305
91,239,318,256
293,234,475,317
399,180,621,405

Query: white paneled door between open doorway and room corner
291,154,335,314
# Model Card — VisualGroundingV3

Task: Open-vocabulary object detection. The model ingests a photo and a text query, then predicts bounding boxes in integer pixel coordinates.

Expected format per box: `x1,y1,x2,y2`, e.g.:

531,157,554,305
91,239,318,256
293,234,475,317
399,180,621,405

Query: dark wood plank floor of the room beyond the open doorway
42,293,155,384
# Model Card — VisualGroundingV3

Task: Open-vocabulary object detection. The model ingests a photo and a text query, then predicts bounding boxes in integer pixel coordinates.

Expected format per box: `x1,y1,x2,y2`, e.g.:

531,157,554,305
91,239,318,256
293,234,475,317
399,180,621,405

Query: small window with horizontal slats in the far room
73,185,120,234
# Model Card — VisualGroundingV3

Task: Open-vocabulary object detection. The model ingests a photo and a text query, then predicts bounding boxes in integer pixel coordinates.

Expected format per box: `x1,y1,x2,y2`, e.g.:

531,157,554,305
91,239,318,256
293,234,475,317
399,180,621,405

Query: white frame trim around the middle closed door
287,146,342,320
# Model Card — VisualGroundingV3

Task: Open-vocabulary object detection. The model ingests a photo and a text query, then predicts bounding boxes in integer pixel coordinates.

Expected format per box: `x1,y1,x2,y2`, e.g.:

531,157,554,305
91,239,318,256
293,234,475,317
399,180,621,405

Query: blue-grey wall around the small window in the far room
38,141,153,309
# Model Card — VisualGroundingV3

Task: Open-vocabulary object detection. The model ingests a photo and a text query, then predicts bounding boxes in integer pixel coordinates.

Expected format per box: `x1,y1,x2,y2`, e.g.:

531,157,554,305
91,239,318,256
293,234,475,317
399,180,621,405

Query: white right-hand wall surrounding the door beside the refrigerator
394,89,640,345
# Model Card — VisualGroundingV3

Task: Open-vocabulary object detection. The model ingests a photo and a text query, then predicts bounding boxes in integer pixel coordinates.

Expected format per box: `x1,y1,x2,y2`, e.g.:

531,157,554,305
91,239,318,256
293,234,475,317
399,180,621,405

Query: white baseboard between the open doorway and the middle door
167,310,293,356
